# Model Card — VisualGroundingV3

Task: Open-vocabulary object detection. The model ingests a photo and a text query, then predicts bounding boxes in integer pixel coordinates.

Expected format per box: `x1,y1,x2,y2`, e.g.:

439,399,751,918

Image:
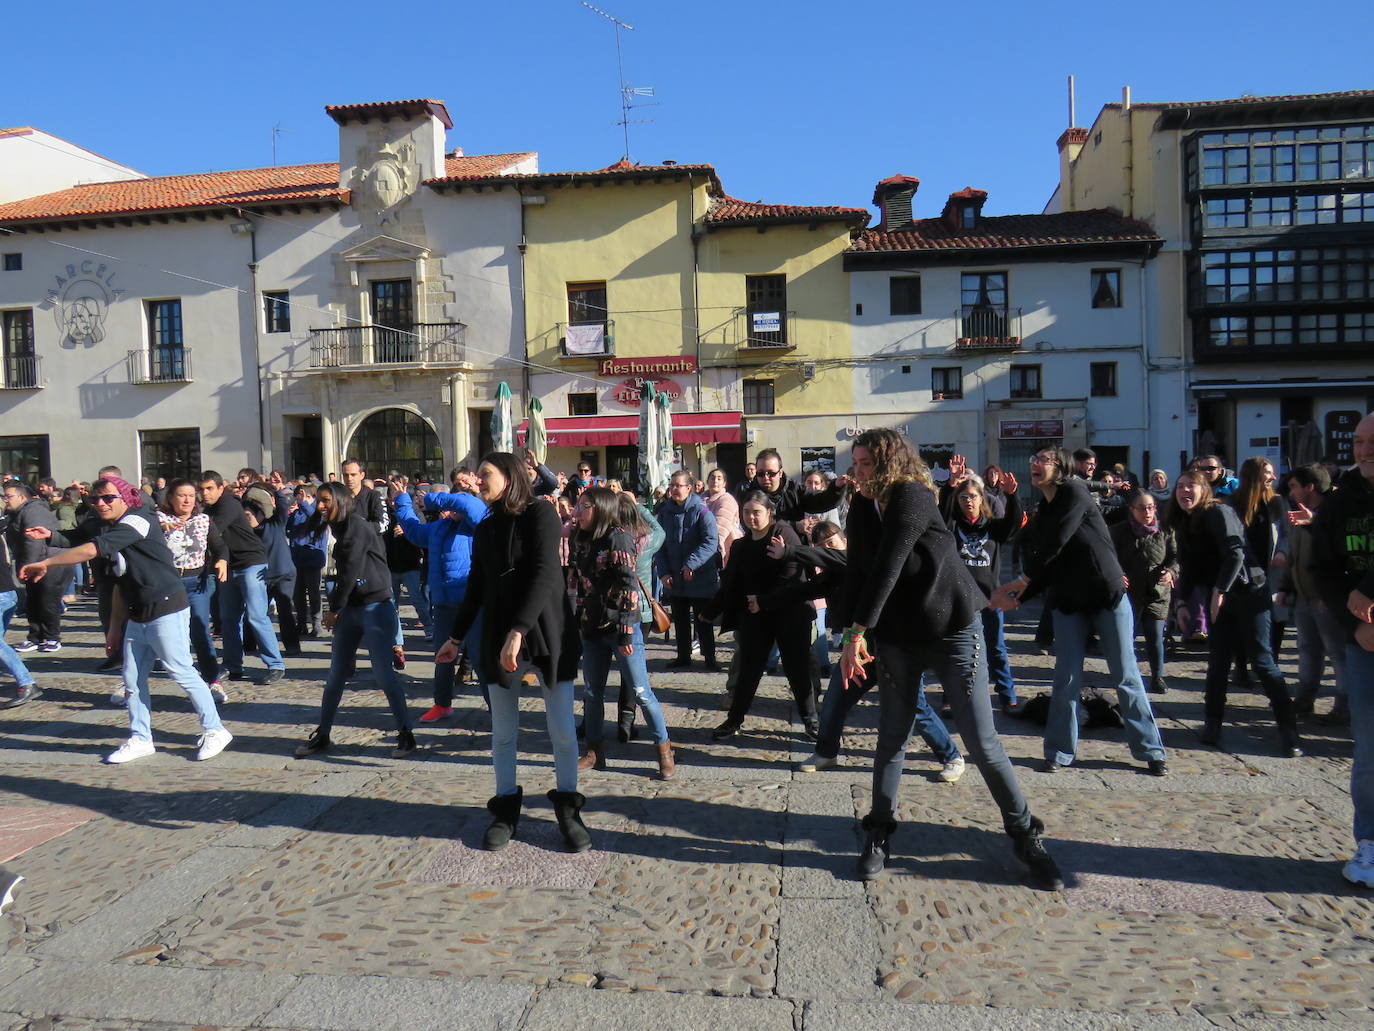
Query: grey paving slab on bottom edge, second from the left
258,976,534,1031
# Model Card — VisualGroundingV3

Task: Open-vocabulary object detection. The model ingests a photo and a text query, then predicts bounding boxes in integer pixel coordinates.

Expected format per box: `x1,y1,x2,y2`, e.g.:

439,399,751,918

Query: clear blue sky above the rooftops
10,0,1374,216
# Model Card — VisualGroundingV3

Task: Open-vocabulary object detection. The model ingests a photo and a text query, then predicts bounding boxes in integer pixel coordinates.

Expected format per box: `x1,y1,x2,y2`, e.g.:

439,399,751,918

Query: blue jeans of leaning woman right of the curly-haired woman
1044,595,1164,766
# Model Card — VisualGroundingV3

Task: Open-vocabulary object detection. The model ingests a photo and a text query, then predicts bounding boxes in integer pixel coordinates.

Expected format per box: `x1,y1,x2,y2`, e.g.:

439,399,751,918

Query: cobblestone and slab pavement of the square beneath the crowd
0,601,1374,1031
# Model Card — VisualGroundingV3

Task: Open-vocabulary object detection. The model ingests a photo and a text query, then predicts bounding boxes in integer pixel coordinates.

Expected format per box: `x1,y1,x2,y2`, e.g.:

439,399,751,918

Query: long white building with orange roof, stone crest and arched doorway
0,100,537,481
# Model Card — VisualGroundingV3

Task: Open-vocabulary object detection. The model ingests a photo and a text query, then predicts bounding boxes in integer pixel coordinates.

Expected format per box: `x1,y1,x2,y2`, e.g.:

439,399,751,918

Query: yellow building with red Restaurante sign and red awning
436,162,868,480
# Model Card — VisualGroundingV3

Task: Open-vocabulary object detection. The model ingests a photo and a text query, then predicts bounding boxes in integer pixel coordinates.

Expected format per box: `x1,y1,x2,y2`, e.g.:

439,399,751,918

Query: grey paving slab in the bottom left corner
0,960,297,1027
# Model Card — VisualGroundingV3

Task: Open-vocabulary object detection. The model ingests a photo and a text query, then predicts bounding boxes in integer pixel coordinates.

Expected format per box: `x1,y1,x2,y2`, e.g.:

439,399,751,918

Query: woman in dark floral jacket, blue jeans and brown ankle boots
572,487,677,781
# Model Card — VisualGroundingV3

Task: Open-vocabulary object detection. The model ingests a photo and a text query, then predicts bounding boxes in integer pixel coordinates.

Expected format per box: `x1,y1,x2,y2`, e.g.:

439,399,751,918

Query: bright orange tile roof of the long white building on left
0,154,529,223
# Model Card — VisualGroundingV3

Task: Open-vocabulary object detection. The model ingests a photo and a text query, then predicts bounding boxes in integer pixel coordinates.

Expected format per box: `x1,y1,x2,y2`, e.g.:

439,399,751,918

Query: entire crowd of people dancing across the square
0,415,1374,889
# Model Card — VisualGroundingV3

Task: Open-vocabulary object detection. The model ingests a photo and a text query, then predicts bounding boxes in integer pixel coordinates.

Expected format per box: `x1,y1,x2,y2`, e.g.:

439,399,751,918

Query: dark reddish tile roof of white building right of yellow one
849,208,1162,252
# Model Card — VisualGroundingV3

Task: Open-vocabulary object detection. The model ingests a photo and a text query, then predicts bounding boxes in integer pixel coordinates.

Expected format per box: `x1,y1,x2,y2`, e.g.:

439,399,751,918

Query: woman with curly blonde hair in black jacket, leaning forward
840,429,1063,891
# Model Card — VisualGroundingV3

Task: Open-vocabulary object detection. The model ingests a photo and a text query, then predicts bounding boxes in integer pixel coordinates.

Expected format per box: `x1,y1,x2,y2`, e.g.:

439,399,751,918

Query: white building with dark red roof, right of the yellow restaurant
845,176,1168,483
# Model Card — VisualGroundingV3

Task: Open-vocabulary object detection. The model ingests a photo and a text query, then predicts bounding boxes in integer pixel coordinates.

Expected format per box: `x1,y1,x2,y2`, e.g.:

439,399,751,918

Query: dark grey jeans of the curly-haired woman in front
868,616,1031,834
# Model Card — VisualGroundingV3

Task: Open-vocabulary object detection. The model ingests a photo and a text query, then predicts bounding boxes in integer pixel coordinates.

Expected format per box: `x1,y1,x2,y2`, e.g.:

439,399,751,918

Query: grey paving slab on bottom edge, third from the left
521,988,794,1031
